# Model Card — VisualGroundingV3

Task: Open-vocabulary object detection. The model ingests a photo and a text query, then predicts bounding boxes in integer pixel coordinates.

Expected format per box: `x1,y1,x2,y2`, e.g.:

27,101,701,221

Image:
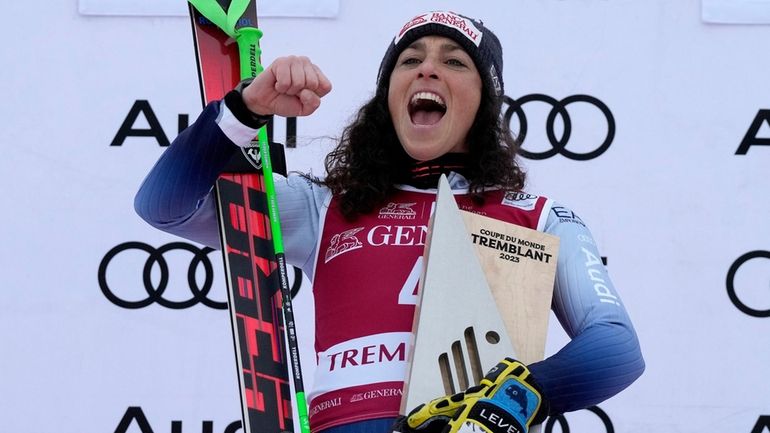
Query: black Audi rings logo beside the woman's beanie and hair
504,93,615,161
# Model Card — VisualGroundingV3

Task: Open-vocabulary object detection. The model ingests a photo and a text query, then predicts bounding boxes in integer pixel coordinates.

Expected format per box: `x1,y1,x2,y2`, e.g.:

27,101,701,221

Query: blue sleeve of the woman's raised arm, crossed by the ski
134,101,328,274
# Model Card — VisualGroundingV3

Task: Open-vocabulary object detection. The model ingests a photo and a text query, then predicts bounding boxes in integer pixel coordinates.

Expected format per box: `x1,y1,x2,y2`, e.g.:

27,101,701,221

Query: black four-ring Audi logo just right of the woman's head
504,93,615,161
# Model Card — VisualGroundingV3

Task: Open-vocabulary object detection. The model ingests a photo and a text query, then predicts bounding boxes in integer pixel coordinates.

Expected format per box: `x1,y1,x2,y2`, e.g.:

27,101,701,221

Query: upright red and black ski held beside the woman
189,0,294,433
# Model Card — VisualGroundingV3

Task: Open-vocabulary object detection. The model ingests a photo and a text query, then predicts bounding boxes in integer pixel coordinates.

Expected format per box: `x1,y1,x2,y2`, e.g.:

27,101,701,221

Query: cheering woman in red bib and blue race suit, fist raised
135,12,644,433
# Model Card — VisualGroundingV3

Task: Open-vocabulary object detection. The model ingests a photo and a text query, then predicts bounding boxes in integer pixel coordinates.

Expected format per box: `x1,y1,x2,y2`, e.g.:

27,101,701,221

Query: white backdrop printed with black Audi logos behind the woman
0,0,770,433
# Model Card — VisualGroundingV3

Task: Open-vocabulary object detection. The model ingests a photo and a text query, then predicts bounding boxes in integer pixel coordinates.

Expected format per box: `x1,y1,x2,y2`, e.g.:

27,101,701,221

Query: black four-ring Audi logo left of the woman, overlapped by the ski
98,241,302,310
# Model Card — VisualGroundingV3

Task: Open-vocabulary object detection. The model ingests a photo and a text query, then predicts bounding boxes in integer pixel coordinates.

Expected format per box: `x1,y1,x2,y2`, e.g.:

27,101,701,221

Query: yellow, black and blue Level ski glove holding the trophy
394,358,548,433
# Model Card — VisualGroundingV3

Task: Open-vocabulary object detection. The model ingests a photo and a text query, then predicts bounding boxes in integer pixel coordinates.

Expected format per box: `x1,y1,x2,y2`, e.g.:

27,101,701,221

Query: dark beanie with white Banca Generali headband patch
377,11,504,96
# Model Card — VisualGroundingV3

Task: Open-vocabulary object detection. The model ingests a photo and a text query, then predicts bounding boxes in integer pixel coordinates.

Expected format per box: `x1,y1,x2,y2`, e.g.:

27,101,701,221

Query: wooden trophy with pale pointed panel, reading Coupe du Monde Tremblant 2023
401,176,559,428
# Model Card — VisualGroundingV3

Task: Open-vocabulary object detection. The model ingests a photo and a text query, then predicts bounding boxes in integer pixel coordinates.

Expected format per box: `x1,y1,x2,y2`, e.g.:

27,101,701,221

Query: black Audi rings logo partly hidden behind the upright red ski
98,242,302,310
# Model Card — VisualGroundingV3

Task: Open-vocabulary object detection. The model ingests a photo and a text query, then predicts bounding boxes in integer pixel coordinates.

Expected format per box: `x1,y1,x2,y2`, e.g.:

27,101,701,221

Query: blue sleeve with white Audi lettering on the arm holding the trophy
530,204,644,414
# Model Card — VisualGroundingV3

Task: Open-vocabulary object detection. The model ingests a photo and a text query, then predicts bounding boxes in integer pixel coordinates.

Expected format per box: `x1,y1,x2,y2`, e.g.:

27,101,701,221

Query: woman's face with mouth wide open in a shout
388,36,482,161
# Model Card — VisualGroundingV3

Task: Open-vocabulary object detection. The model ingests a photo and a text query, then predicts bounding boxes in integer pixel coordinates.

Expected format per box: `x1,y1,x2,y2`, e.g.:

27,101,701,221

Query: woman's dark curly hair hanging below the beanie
308,82,526,220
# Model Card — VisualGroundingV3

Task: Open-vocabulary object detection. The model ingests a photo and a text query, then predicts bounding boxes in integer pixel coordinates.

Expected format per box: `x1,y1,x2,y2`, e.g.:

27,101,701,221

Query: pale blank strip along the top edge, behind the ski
78,0,339,18
